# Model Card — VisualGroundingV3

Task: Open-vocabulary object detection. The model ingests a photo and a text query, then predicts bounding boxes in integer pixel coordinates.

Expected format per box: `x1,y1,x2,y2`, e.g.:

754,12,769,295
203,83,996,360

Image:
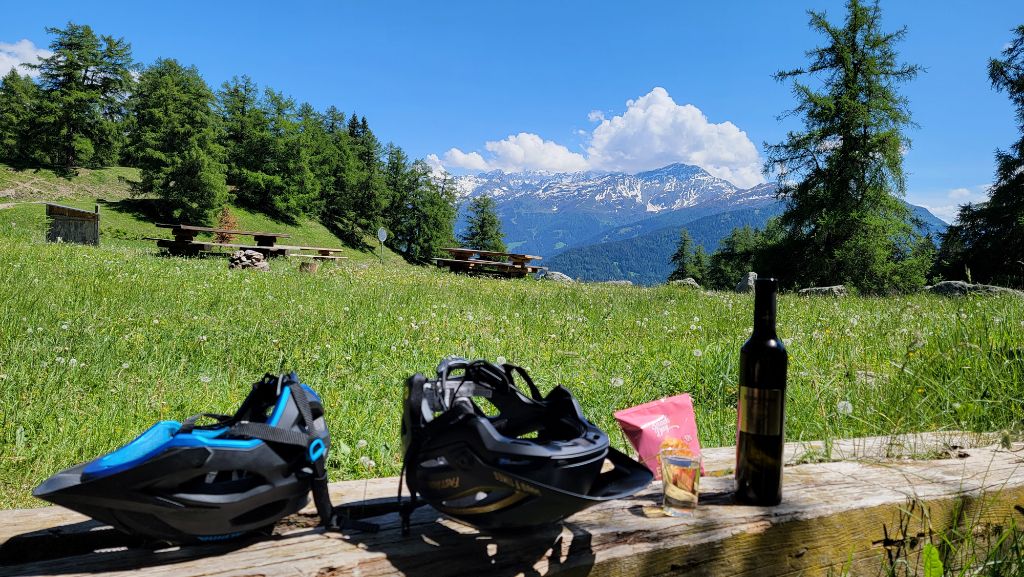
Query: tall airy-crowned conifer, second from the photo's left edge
32,23,136,170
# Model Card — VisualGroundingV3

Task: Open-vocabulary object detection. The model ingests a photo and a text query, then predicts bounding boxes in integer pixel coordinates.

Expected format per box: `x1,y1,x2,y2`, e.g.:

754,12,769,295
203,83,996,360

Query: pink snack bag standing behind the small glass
615,393,703,479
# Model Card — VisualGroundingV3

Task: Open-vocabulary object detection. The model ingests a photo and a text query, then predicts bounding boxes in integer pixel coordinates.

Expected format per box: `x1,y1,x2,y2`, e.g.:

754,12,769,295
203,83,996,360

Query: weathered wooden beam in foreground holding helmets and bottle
0,431,1024,577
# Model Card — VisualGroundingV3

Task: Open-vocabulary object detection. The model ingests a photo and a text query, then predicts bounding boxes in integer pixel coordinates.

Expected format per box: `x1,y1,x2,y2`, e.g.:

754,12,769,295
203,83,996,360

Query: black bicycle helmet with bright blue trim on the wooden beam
33,373,331,542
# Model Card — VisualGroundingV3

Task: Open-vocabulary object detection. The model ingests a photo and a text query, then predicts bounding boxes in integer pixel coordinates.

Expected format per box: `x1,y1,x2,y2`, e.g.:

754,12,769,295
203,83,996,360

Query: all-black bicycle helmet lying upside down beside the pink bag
401,359,652,530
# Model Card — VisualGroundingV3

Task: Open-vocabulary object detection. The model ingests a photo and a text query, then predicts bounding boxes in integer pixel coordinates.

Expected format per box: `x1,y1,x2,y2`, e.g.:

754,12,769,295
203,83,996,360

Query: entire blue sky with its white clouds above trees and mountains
0,0,1024,221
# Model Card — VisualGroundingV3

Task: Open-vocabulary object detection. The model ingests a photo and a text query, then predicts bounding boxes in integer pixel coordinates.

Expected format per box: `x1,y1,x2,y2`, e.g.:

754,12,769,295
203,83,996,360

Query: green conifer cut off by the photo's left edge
0,69,39,166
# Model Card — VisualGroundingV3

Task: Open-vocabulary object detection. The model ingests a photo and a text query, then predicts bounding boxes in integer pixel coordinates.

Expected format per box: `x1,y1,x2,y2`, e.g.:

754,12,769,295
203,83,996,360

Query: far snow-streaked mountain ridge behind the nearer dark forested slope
456,164,775,255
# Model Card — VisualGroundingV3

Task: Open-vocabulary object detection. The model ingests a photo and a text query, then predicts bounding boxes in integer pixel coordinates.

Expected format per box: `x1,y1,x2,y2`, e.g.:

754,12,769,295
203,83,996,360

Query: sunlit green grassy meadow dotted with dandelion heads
0,201,1024,507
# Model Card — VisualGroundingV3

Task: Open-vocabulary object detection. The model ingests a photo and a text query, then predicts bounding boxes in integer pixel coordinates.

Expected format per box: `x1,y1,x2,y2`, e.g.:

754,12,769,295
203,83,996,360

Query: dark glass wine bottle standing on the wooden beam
736,278,788,505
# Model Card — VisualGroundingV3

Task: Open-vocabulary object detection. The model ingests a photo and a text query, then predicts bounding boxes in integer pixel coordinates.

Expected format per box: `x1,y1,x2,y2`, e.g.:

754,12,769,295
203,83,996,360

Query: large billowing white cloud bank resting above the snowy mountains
428,87,764,188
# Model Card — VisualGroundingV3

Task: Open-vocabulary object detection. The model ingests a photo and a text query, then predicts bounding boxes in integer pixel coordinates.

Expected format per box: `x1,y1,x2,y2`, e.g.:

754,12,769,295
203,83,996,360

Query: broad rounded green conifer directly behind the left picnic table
129,58,227,223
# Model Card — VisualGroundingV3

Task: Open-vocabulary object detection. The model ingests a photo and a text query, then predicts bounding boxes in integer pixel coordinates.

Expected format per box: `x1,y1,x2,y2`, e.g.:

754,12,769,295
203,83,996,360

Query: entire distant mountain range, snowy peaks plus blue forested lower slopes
456,164,946,284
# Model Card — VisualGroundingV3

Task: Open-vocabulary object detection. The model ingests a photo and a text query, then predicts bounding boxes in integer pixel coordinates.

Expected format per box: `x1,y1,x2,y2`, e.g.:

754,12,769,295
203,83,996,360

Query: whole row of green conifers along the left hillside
0,23,456,262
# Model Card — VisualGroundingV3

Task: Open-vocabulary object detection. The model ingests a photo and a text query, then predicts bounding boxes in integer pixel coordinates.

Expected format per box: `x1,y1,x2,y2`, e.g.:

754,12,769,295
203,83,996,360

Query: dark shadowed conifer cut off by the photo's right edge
937,25,1024,288
